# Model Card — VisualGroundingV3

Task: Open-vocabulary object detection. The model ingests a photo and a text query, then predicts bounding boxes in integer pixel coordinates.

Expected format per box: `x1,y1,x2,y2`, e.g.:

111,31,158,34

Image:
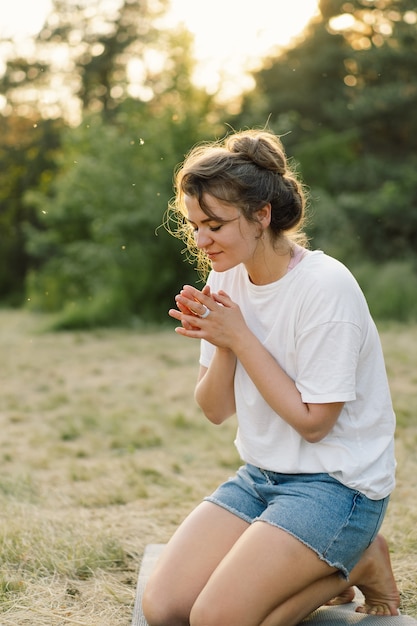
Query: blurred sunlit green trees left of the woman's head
0,0,223,312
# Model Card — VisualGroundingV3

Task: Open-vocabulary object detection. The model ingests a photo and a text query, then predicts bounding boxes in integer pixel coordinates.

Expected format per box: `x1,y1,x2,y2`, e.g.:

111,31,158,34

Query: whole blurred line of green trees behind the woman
0,0,417,327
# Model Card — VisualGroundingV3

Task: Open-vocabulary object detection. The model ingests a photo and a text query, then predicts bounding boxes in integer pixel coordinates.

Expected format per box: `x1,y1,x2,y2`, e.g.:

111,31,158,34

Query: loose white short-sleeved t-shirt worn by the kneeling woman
200,251,395,500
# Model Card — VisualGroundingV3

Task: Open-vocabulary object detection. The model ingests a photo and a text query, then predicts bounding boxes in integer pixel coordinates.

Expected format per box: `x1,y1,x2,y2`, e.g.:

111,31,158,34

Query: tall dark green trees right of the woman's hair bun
234,0,417,262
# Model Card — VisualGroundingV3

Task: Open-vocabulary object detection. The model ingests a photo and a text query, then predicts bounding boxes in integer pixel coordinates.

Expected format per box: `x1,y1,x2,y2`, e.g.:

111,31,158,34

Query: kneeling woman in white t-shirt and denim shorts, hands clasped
143,130,399,626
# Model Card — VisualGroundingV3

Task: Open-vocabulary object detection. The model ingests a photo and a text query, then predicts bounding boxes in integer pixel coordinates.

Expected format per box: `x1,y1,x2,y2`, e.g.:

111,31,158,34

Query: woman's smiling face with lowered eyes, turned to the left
184,194,262,274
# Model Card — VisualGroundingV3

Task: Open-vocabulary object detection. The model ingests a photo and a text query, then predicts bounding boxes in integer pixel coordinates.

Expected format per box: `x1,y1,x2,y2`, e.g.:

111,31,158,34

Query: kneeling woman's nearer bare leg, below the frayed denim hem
190,522,348,626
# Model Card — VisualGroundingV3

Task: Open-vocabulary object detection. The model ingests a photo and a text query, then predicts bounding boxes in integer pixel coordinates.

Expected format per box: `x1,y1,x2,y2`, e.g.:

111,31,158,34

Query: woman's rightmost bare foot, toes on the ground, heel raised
352,535,400,615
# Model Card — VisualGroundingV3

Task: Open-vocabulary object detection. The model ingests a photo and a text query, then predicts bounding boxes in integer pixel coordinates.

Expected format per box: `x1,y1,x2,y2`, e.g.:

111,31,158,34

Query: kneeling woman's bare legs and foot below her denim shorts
143,502,399,626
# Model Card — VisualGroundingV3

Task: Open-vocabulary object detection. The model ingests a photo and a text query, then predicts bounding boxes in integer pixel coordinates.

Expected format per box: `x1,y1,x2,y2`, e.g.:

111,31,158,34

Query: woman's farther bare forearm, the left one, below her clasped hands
194,348,236,424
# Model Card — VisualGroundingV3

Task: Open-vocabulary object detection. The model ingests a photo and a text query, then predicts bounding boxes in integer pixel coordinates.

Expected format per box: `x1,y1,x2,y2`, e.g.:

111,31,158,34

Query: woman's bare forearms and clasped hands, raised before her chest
170,287,343,436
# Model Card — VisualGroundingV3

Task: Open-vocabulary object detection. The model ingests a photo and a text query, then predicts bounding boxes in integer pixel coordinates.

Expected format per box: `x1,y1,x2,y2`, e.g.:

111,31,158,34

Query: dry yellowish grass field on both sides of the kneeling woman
0,311,417,626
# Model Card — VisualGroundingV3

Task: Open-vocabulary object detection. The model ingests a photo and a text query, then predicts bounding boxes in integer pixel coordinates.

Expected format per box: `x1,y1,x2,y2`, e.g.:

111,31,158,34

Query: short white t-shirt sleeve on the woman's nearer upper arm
295,263,369,403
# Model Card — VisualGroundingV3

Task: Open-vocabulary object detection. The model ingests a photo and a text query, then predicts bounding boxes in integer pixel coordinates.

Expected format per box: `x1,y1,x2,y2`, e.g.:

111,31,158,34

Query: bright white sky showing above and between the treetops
0,0,318,99
